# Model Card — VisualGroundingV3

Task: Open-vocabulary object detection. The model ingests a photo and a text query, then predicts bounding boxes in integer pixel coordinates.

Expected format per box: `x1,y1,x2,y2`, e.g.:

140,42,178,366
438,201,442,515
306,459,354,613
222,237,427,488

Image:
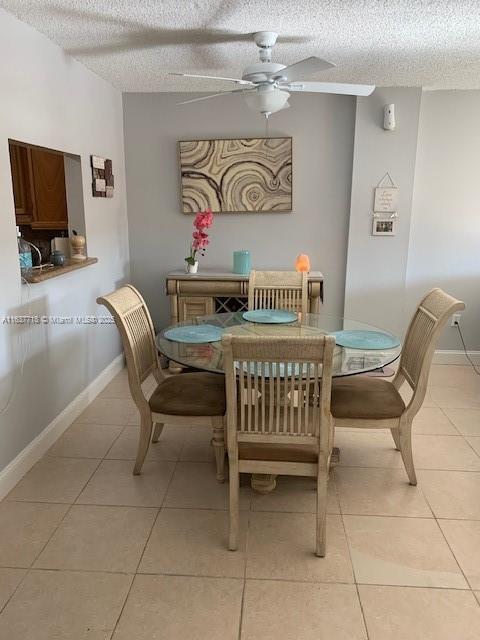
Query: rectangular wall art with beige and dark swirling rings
179,138,292,213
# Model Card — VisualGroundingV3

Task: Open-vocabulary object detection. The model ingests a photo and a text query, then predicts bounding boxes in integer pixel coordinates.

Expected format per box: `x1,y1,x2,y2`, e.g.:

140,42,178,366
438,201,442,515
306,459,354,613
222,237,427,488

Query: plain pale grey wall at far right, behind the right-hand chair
407,91,480,351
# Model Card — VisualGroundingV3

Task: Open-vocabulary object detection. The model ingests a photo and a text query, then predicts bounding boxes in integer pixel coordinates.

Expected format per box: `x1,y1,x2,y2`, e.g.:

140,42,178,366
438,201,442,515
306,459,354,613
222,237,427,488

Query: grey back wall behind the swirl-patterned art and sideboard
123,93,355,326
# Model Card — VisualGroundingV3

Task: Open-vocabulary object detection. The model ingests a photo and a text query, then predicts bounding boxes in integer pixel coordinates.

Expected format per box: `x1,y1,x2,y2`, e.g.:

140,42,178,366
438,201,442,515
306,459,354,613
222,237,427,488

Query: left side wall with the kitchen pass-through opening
0,9,128,470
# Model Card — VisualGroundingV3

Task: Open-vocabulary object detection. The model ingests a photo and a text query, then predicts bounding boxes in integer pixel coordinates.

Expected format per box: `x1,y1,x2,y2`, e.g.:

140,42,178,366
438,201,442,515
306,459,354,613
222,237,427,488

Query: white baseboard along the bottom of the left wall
0,354,124,500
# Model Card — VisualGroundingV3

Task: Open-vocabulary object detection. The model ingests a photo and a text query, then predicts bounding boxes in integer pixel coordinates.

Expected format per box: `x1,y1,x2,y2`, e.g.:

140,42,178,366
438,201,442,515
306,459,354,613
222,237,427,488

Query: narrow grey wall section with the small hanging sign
345,87,421,334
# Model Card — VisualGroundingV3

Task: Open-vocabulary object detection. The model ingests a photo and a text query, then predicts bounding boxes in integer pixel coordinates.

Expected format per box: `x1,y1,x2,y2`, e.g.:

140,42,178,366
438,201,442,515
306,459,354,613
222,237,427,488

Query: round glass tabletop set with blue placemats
156,311,401,377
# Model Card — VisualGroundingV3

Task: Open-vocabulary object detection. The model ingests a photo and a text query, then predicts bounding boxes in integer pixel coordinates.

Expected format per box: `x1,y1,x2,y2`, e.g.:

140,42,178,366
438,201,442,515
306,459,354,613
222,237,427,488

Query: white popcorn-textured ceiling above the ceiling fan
0,0,480,91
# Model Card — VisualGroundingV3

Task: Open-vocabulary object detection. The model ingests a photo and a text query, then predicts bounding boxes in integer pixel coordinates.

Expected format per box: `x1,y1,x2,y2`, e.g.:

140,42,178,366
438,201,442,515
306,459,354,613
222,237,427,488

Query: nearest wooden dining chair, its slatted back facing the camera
222,335,335,556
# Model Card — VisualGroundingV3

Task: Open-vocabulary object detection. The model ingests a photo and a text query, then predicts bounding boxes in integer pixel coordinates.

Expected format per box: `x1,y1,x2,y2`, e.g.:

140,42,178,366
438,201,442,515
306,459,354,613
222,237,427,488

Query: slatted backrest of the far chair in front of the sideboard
248,271,308,314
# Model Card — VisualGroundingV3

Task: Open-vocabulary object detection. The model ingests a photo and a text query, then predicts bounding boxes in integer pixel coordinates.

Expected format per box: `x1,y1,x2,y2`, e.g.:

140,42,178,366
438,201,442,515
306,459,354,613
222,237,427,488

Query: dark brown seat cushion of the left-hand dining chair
149,373,226,416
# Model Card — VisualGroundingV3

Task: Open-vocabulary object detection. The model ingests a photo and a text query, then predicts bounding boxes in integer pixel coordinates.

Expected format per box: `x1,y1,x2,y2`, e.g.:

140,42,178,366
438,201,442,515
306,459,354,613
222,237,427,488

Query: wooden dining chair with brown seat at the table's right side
332,289,465,485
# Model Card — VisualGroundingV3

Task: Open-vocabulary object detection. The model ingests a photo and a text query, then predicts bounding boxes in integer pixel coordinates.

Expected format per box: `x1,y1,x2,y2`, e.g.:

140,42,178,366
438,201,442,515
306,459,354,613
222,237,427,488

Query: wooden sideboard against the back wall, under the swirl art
167,270,323,324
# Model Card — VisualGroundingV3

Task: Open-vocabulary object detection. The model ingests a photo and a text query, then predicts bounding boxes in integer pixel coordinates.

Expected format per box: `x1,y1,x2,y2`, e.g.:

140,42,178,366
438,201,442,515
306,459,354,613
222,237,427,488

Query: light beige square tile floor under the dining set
0,365,480,640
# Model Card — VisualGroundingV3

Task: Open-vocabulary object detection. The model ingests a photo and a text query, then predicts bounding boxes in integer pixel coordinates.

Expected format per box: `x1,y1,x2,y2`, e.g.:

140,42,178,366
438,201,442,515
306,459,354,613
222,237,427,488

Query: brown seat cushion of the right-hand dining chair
331,376,405,420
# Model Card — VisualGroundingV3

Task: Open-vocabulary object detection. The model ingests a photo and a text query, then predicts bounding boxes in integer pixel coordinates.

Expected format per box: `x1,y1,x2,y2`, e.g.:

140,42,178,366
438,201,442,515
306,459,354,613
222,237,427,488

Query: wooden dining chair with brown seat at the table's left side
97,285,226,482
